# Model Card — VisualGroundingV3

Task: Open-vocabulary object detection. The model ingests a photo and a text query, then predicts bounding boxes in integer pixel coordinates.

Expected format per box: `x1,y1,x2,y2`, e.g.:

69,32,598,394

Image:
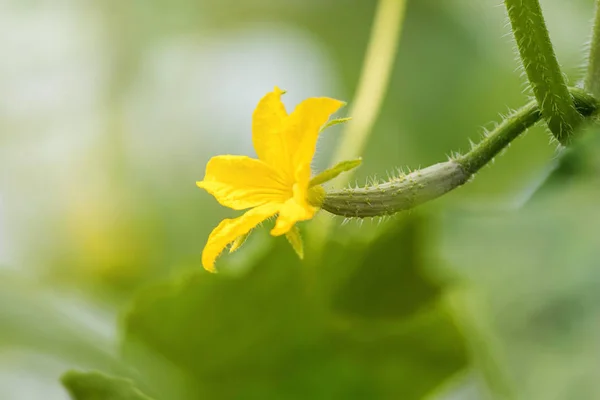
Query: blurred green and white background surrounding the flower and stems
0,0,600,400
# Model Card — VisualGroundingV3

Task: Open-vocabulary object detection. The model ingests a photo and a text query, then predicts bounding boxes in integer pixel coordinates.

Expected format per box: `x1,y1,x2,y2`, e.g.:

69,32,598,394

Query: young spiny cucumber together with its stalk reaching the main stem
321,88,598,218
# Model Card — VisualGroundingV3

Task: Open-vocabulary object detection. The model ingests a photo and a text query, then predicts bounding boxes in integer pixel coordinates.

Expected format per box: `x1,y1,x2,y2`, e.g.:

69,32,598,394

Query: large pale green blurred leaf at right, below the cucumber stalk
444,136,600,400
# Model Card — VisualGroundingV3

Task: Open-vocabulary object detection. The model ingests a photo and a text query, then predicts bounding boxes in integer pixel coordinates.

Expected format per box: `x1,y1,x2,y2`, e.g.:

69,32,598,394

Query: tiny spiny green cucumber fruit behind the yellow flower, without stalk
321,161,470,218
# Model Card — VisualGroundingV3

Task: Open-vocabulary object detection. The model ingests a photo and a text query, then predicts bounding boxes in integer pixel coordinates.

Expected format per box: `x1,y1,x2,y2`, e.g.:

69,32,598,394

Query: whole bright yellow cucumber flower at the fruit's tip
197,87,356,271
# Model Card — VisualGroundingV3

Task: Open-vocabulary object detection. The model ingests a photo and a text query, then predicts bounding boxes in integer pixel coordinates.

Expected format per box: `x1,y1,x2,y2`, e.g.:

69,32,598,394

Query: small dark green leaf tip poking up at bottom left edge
61,371,152,400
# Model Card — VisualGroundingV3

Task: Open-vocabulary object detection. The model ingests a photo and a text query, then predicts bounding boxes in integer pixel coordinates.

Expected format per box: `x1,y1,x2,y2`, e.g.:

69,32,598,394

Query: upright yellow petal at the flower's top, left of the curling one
252,87,289,174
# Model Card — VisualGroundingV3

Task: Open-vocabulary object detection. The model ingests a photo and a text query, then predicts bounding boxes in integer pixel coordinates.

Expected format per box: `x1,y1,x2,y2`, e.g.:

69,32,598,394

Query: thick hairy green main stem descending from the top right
504,0,582,145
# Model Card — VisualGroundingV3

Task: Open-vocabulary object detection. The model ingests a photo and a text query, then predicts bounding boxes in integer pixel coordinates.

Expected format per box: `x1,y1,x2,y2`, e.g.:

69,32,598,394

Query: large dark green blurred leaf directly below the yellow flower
123,220,466,399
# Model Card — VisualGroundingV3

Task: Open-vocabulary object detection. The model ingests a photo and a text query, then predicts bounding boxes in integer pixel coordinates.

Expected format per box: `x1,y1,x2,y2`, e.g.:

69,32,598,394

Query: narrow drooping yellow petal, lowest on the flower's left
202,204,281,272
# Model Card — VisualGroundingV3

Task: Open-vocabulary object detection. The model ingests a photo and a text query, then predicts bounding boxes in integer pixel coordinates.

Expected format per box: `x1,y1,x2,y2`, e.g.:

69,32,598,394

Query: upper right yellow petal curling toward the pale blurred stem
285,97,345,173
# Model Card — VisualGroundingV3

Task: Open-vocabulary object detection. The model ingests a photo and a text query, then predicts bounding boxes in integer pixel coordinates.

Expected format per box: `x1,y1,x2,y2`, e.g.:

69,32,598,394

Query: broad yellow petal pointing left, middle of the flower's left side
196,156,291,210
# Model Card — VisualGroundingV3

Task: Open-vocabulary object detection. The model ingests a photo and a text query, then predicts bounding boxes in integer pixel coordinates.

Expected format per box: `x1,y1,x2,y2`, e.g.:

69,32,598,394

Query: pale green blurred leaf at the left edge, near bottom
0,273,126,370
